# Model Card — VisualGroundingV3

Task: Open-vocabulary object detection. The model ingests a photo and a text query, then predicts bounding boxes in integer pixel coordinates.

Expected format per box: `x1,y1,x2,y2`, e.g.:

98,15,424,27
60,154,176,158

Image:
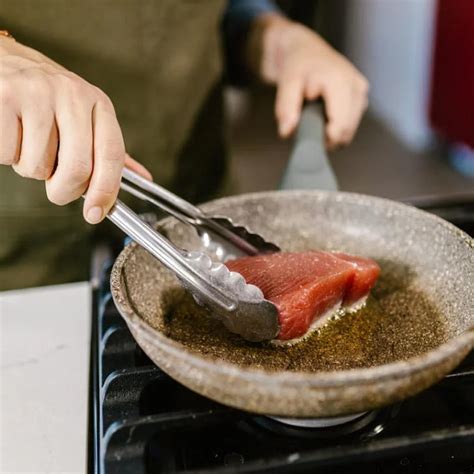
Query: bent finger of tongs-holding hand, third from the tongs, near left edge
10,108,58,180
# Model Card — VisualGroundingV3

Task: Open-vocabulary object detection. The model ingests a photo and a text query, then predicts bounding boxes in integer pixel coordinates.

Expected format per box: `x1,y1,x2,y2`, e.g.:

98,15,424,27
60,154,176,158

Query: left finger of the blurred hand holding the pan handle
275,74,304,138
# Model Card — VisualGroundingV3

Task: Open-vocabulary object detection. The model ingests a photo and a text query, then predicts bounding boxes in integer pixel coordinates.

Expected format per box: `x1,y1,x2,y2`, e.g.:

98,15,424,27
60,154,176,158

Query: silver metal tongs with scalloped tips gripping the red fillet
107,168,279,342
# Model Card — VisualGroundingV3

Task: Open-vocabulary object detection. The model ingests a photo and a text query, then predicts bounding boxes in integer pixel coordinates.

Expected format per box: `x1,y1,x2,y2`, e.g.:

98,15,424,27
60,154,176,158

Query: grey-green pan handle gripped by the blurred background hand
280,101,338,191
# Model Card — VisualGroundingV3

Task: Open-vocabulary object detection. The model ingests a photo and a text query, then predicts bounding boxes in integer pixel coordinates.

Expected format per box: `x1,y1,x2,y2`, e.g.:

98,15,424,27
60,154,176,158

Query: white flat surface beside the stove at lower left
0,282,91,473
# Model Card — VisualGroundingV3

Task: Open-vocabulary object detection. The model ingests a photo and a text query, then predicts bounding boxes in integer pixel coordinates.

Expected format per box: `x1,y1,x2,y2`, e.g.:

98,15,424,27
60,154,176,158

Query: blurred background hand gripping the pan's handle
246,14,369,149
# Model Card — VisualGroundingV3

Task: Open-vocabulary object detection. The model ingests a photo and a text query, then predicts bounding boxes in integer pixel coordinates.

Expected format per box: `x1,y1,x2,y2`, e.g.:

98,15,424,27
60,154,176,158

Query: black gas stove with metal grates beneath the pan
89,196,474,474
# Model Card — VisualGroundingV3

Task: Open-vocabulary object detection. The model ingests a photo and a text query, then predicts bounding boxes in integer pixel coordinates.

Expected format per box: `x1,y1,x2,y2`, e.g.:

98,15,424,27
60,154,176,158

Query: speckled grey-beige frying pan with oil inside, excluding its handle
111,191,474,417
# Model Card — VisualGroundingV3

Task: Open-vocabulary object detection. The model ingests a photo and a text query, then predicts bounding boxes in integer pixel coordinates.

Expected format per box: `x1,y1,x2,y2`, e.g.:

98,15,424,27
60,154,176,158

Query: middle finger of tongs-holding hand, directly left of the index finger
46,100,93,206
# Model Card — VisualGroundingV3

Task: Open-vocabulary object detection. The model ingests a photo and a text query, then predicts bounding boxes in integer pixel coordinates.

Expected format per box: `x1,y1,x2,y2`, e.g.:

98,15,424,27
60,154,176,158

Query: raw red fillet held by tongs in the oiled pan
226,251,380,341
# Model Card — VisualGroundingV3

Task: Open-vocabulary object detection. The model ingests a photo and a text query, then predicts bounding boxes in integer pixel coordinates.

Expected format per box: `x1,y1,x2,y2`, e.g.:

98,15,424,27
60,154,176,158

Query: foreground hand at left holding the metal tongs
0,38,151,224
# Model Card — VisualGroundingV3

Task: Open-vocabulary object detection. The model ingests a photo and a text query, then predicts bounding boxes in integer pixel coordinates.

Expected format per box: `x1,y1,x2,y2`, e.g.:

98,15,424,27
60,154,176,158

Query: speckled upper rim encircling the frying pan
111,190,474,387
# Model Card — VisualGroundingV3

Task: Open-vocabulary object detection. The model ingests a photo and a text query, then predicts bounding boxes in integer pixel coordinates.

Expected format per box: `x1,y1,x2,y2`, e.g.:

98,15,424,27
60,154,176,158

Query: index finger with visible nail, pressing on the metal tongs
84,100,125,224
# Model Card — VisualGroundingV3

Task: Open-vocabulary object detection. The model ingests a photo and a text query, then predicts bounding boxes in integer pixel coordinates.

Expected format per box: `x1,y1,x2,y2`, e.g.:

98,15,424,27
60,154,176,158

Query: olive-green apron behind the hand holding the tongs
0,0,230,290
